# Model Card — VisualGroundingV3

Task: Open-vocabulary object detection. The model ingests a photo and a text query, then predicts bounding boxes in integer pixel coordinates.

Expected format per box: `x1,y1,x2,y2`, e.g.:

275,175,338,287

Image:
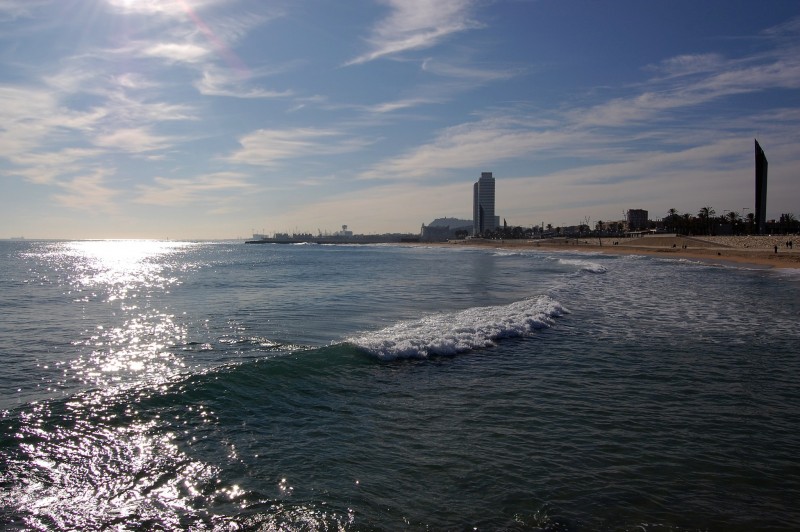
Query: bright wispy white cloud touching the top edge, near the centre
347,0,481,65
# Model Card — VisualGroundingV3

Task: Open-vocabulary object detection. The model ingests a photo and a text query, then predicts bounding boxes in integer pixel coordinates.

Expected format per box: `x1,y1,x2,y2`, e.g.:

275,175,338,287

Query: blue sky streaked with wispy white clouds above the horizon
0,0,800,239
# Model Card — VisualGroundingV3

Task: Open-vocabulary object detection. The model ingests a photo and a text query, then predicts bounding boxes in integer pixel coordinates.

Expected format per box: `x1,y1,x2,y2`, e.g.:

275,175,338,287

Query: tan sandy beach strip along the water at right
438,235,800,268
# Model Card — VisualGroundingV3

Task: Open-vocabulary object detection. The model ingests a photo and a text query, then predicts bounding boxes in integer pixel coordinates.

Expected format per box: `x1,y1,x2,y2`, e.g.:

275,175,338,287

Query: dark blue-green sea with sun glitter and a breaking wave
0,241,800,531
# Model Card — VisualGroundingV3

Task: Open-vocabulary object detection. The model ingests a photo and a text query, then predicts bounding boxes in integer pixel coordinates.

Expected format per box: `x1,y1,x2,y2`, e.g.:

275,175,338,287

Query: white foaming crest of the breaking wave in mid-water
347,296,567,360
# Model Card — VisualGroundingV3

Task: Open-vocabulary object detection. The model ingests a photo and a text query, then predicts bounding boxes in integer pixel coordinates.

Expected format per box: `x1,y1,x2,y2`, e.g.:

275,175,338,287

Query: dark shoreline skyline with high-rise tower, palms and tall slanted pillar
252,140,800,244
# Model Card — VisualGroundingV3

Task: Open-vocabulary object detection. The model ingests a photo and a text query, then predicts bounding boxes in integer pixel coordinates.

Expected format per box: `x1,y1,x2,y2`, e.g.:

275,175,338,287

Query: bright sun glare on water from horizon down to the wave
52,240,191,386
